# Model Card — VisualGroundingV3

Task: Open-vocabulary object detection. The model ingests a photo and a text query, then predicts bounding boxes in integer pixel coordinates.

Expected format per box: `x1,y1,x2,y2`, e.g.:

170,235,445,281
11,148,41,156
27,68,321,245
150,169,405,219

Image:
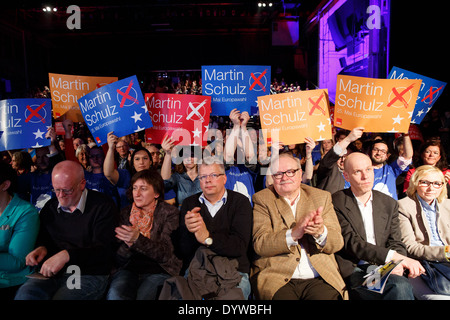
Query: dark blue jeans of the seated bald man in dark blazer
347,265,414,300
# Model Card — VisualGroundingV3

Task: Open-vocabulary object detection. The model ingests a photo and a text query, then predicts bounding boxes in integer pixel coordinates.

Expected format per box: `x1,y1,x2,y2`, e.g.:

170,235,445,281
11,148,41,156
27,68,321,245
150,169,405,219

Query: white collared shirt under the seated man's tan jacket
284,192,328,279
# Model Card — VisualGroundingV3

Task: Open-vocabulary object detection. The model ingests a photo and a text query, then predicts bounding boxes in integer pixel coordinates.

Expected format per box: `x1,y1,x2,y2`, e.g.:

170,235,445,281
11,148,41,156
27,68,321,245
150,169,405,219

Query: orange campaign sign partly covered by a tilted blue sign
48,73,118,122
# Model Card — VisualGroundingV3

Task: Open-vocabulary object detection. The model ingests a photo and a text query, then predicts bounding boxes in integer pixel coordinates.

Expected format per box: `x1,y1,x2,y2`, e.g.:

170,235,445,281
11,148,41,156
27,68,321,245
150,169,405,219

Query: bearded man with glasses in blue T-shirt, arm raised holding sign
360,134,414,200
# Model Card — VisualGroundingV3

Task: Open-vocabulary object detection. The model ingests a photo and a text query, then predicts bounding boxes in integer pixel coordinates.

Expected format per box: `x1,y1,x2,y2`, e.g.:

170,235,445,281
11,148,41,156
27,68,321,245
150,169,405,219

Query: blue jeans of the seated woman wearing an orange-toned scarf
106,270,170,300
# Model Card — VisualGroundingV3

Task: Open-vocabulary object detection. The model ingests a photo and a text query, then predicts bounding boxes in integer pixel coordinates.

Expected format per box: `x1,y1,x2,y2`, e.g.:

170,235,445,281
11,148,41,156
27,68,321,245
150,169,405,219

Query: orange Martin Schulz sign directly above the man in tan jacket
258,89,332,145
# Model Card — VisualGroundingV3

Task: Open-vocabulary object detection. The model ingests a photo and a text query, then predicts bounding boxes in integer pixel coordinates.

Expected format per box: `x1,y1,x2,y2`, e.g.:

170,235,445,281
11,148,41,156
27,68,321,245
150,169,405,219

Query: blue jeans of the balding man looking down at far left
15,274,109,300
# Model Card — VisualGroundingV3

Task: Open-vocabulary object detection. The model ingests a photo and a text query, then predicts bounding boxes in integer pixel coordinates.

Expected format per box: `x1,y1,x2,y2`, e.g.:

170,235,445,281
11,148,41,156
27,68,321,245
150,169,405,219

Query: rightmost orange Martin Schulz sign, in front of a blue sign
334,75,422,133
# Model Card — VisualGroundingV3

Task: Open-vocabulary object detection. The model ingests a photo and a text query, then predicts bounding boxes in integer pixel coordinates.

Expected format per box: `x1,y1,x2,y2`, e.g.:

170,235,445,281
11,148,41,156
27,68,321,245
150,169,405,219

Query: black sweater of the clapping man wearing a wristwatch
179,190,253,273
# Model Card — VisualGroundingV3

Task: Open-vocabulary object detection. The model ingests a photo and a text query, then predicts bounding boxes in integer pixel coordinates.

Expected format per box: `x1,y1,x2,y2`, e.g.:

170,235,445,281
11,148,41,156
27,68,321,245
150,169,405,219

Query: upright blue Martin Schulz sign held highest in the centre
202,66,271,116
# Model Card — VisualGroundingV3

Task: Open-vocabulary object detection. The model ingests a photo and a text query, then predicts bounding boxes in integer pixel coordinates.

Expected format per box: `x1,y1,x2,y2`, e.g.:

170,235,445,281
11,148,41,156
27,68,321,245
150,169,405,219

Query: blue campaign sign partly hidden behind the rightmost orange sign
389,67,447,124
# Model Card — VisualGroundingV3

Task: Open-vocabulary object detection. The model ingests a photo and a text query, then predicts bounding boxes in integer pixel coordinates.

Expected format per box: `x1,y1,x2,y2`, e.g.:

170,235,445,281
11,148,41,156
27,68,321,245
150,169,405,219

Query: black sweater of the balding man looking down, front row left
36,190,119,275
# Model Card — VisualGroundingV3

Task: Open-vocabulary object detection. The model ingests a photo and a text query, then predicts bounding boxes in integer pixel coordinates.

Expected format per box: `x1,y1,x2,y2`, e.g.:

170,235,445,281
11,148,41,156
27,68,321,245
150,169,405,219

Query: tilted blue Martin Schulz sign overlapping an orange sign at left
78,76,153,146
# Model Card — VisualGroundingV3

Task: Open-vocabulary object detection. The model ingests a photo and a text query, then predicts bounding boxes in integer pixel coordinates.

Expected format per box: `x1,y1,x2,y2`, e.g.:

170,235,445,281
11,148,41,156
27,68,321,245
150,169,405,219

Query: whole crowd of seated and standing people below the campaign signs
0,79,450,300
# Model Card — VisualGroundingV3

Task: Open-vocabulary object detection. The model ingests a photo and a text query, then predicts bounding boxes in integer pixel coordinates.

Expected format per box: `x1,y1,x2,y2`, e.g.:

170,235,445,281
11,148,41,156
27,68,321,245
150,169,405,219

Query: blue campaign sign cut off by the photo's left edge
0,99,52,151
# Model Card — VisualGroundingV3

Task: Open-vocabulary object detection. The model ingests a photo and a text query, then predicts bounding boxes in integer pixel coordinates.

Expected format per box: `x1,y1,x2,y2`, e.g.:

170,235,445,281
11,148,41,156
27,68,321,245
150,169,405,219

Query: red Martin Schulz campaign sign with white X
145,93,211,146
